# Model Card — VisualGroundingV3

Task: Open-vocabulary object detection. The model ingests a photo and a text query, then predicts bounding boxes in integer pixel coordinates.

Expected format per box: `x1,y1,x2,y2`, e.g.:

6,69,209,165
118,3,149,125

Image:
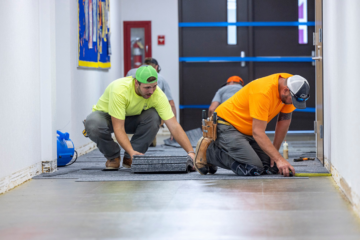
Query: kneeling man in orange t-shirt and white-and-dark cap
195,73,310,177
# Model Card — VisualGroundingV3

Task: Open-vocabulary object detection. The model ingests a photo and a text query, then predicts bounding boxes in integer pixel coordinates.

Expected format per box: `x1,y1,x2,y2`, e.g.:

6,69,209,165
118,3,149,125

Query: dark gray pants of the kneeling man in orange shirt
206,124,278,176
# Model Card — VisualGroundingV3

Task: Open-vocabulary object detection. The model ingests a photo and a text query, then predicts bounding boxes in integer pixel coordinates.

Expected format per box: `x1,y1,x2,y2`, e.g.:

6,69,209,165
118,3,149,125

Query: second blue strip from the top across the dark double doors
179,57,314,62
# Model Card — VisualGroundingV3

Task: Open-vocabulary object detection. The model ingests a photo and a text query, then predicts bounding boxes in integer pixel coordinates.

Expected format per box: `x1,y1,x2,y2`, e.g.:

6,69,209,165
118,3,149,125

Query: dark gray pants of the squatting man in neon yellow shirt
85,108,160,159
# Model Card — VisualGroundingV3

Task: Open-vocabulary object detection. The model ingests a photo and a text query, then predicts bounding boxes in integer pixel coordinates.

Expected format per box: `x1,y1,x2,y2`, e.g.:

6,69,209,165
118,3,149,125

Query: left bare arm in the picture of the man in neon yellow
111,117,143,158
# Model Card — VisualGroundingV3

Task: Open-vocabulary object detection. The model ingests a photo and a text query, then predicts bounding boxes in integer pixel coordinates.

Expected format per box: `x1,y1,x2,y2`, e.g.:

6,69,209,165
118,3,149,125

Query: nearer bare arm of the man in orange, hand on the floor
252,118,295,177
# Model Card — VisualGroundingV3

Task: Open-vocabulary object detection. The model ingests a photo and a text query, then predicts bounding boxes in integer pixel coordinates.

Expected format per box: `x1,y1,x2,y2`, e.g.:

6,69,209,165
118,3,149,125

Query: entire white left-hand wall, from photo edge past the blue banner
0,0,123,184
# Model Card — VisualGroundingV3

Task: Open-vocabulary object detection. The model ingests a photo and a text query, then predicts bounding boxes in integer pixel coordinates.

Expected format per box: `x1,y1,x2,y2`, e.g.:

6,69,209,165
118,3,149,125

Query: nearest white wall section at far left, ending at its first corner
0,0,41,178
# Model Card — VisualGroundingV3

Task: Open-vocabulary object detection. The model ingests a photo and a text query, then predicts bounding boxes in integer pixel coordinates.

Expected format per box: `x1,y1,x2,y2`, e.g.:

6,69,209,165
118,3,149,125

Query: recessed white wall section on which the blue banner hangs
56,0,123,148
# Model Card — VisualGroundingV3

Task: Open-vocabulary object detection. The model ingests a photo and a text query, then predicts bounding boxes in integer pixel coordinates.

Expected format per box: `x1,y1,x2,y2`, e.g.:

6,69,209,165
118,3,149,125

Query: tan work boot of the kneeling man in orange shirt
194,137,212,175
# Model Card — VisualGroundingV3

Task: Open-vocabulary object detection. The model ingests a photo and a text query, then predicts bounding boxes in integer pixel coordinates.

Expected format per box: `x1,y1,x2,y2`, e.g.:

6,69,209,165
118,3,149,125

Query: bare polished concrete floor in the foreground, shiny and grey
0,177,360,240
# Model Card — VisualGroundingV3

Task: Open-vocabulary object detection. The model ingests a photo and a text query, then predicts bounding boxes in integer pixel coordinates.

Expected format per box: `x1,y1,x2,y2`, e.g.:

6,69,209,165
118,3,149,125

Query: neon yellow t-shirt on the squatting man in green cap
92,76,174,120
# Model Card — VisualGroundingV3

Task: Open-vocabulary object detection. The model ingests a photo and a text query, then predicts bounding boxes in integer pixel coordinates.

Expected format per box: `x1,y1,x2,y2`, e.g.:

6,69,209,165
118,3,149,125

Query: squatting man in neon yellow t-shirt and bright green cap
85,66,195,169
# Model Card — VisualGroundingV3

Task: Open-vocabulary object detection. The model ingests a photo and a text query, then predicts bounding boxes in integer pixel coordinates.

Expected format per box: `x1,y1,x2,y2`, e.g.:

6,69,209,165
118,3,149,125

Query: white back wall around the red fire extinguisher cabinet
118,0,179,120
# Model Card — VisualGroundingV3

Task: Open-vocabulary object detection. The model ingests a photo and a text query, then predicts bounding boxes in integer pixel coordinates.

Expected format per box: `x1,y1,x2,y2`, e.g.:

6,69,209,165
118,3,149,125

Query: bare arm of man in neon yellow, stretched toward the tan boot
165,117,195,160
